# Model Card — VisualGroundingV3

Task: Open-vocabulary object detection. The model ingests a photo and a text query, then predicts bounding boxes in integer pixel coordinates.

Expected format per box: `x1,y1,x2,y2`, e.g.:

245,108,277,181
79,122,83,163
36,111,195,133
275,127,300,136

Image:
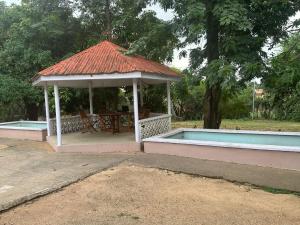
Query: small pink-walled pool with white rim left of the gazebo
0,121,47,141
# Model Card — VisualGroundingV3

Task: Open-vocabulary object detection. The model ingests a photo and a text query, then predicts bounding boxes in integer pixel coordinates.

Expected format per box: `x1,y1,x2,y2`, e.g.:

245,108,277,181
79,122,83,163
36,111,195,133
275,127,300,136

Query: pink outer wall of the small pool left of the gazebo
0,128,47,141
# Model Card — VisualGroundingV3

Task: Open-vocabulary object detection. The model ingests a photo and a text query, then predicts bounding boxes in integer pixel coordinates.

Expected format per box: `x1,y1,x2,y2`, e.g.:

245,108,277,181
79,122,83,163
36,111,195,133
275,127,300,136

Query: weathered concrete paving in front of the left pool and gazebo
0,139,132,211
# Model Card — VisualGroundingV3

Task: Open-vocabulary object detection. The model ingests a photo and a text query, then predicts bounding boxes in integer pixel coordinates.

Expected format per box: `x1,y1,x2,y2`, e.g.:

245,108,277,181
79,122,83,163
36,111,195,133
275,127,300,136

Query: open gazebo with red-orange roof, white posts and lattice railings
33,41,180,151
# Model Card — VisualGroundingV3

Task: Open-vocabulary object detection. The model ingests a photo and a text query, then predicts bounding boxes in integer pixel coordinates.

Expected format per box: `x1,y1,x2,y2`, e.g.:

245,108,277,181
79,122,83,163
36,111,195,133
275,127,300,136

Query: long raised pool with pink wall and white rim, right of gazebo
143,128,300,170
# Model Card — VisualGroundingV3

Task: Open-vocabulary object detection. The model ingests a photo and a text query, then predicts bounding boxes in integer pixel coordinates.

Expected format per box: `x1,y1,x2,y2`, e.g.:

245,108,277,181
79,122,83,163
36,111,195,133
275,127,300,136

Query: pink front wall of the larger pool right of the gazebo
144,141,300,171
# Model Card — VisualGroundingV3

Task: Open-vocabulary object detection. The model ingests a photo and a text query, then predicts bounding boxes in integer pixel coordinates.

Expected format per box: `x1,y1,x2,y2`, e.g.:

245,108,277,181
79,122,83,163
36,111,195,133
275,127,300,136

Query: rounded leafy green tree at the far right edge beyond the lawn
263,31,300,121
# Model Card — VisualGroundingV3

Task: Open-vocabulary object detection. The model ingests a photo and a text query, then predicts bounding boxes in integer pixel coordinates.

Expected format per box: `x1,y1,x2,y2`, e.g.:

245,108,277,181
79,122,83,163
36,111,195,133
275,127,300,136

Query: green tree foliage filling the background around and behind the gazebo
0,0,300,123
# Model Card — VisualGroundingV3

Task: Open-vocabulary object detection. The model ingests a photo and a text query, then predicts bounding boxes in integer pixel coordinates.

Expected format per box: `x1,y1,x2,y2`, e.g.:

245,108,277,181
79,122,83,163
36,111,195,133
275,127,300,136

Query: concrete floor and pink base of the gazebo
47,131,141,153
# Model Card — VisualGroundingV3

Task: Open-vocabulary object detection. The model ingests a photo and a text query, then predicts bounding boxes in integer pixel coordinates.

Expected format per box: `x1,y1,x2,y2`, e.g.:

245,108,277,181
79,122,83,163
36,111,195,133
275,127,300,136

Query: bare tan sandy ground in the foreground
0,164,300,225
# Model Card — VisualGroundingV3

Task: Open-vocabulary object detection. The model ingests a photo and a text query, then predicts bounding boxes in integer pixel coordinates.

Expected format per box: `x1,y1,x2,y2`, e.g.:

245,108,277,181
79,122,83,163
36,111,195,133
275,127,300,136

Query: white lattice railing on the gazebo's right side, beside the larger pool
139,114,172,140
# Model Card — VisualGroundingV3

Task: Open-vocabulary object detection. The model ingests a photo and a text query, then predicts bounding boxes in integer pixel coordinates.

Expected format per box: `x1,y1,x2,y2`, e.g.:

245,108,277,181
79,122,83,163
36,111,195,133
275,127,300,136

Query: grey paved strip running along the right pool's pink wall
129,154,300,193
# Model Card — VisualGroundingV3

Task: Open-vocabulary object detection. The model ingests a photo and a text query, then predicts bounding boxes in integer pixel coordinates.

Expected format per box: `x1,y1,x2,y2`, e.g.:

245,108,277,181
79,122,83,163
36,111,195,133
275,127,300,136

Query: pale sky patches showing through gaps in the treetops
4,0,300,69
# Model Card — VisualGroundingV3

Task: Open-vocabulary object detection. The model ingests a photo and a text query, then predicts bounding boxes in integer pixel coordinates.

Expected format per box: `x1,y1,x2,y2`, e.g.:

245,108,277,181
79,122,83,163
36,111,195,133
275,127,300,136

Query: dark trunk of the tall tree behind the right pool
203,0,221,129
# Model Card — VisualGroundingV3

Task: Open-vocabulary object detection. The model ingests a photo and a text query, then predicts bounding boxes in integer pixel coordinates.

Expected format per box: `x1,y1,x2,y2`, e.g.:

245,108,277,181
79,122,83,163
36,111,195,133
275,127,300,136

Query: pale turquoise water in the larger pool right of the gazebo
165,131,300,147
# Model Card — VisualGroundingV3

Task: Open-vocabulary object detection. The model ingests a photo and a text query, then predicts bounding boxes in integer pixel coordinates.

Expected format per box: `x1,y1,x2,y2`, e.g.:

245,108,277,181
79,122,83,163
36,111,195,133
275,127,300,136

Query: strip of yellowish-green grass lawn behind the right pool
172,120,300,132
